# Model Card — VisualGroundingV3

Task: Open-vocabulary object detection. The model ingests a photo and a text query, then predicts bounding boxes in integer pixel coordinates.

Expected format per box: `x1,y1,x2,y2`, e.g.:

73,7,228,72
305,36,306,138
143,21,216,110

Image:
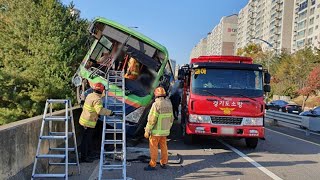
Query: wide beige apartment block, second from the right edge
236,0,295,53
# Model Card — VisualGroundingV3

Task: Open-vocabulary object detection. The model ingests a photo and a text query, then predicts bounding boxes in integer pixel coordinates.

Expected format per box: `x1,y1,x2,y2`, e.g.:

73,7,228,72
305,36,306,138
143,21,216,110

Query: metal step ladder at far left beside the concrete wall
31,99,80,179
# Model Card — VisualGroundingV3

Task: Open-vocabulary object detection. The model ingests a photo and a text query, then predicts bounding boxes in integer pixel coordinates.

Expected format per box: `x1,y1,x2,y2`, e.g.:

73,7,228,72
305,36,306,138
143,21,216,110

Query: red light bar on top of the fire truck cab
190,56,253,64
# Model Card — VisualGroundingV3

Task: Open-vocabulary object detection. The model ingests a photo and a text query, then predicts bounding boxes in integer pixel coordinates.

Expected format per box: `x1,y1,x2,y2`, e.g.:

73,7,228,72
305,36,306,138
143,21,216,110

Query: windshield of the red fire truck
191,68,263,97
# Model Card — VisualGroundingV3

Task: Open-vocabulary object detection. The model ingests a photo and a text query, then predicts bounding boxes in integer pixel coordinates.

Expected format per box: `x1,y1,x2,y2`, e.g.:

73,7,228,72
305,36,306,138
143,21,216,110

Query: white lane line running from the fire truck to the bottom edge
218,140,282,180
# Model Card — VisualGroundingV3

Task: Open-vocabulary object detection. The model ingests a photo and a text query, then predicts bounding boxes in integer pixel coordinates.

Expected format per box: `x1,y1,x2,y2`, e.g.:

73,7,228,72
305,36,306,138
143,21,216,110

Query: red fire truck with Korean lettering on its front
179,56,270,148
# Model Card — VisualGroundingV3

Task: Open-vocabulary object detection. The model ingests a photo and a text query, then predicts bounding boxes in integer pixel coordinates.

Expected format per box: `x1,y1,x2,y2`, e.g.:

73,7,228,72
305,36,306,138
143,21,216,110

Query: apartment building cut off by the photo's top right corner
291,0,320,52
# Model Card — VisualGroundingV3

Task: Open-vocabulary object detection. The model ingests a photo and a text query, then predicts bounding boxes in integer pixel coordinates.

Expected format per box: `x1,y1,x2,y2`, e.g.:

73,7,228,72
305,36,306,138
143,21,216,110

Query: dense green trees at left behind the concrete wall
0,0,88,124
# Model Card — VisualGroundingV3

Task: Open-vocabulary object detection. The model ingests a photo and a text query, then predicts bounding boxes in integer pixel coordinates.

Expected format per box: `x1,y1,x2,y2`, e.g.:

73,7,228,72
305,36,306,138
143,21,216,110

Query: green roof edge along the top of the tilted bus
93,17,169,58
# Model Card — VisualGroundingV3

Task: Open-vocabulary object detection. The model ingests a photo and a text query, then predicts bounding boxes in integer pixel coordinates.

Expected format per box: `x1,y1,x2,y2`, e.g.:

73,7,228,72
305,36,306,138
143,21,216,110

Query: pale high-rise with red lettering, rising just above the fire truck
206,14,238,55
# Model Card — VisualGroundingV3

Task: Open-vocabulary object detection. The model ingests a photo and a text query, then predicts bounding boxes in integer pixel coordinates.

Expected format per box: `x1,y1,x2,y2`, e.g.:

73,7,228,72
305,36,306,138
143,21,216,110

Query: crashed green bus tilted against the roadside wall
73,18,173,136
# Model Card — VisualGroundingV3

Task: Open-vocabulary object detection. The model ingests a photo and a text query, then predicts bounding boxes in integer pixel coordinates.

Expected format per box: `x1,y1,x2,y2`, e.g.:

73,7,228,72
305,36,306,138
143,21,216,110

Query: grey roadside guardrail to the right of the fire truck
266,110,320,136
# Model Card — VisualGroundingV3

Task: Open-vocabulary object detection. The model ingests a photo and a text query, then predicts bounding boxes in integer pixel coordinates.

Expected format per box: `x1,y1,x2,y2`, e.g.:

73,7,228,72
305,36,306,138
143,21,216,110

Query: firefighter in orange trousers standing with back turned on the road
144,87,173,171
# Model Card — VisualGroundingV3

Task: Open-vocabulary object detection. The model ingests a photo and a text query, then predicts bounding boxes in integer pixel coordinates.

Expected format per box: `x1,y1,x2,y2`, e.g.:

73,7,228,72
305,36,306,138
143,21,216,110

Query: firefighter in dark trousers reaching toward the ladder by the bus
79,82,114,162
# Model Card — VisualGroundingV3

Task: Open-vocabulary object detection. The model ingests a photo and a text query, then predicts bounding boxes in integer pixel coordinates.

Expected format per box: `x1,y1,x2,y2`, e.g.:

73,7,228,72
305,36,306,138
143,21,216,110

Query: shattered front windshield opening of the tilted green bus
84,23,169,97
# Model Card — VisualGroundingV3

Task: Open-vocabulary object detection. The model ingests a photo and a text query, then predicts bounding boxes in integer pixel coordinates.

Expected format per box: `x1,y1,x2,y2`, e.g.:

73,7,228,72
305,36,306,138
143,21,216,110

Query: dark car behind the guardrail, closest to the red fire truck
266,100,302,114
